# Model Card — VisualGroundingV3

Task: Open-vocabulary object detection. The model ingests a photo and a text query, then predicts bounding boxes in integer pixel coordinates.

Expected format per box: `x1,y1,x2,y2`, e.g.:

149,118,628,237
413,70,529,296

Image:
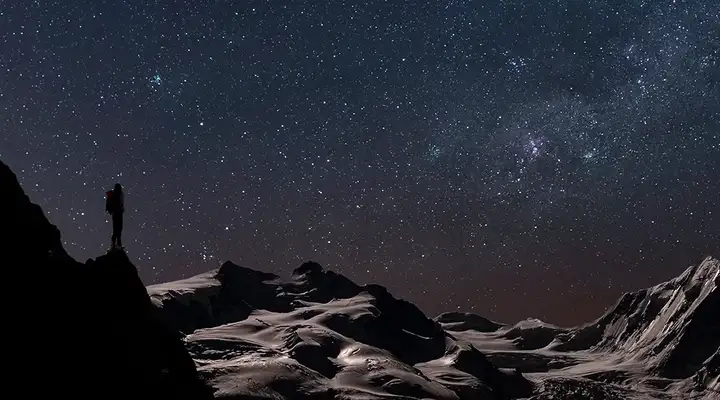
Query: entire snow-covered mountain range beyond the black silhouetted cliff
147,258,720,400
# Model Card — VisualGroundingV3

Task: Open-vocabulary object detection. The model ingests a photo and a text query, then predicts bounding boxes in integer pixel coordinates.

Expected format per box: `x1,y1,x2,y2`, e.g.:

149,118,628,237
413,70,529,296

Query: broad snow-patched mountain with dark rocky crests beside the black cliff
148,262,532,399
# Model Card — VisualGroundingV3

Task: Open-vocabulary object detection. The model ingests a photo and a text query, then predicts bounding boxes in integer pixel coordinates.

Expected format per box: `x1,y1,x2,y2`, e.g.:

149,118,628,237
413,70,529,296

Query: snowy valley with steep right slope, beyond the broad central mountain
444,257,720,399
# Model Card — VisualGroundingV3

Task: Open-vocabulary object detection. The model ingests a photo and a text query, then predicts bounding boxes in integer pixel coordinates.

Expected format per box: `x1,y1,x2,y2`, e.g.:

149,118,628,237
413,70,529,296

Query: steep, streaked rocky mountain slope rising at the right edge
556,257,720,378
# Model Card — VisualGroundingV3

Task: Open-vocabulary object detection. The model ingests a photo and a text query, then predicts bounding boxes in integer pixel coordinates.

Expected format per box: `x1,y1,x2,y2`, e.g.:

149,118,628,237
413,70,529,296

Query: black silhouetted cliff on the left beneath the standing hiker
0,162,211,399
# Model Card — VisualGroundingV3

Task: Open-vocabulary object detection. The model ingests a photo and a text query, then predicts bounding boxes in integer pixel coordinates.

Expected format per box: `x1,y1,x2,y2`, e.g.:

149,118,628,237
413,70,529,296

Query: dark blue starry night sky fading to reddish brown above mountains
0,0,720,325
